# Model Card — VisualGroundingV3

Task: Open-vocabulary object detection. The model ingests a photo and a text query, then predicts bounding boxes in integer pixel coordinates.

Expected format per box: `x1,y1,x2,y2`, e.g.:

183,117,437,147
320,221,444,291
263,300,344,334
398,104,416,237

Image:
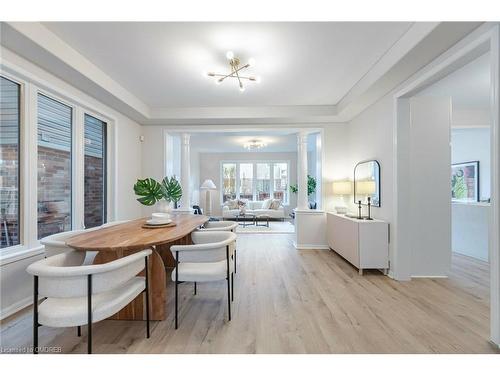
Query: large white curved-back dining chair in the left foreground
27,250,151,354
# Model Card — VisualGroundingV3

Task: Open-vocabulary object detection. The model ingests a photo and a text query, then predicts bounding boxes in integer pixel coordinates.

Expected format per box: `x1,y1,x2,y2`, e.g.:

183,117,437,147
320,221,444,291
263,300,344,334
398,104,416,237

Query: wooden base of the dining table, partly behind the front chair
94,249,167,320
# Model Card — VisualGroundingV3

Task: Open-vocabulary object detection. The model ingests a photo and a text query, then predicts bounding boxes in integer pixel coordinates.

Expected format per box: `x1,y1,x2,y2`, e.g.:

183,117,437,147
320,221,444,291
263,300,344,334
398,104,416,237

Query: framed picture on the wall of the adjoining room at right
451,161,479,202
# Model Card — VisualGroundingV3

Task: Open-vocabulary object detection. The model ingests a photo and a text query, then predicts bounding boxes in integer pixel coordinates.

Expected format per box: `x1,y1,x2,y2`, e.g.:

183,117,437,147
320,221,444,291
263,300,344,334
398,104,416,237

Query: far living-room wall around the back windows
200,152,297,216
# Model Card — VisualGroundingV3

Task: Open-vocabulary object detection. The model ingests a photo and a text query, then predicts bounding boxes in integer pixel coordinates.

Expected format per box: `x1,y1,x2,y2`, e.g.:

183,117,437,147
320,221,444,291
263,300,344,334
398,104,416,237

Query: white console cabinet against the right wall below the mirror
327,212,389,275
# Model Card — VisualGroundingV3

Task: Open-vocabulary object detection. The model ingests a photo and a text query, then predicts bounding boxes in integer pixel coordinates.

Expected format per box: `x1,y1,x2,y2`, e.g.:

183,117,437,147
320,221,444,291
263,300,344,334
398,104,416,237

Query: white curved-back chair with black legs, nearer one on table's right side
170,231,236,329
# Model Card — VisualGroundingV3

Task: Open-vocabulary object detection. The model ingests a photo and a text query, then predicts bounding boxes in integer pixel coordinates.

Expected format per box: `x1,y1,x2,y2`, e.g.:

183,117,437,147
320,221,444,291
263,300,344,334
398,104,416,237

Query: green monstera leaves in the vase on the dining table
134,176,182,206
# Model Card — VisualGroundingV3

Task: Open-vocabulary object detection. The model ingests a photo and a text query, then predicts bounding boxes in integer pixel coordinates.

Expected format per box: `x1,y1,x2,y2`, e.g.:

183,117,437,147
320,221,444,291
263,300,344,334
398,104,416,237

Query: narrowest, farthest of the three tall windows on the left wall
84,114,106,228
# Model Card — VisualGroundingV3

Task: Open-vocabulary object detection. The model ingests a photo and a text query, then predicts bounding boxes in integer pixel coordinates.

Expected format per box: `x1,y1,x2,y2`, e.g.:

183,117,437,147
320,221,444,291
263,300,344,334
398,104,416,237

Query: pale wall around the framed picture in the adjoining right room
451,128,491,200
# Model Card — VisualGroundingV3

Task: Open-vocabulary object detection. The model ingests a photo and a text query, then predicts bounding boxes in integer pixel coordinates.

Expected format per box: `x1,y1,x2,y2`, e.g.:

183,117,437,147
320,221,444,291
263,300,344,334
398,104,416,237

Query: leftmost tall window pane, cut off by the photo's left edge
0,77,21,248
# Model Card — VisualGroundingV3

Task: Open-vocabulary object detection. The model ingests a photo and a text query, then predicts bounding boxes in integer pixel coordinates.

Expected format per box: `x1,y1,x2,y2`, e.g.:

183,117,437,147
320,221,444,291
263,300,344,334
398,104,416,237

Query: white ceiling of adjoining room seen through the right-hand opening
418,53,491,109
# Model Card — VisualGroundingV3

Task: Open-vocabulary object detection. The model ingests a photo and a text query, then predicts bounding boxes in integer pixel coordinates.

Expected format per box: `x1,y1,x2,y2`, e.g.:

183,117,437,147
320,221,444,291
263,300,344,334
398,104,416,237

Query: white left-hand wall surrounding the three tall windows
0,49,142,318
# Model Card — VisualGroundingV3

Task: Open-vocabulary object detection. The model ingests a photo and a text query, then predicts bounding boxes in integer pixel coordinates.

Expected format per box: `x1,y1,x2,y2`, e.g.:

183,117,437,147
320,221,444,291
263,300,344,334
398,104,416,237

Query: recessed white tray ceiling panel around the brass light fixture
44,22,412,108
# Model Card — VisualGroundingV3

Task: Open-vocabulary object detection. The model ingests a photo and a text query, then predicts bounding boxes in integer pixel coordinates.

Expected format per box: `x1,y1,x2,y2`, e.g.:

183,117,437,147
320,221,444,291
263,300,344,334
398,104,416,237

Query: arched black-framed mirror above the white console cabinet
354,160,380,207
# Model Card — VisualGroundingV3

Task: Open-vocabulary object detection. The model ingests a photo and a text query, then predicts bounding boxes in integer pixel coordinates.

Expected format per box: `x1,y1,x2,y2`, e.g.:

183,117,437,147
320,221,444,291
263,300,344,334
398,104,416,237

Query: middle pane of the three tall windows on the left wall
37,94,73,239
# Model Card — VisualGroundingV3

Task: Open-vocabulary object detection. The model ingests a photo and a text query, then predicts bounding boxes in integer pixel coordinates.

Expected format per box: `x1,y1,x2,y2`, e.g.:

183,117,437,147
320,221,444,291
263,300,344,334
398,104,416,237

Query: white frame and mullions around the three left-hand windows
0,69,117,266
